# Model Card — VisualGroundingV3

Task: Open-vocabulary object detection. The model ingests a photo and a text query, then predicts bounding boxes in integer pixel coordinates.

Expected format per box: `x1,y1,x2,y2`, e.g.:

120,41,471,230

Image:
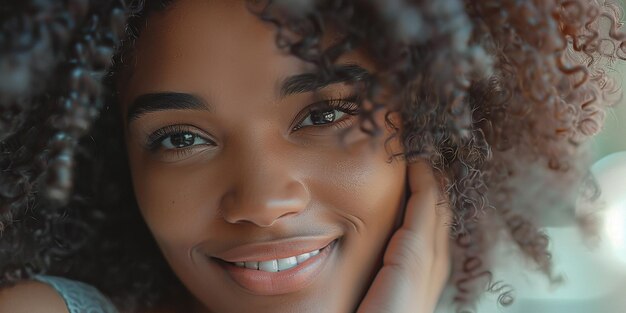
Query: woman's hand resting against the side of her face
358,161,439,313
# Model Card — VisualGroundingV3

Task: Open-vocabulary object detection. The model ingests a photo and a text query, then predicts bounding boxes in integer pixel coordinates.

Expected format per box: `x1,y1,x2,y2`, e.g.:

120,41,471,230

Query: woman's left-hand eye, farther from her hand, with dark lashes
147,125,216,151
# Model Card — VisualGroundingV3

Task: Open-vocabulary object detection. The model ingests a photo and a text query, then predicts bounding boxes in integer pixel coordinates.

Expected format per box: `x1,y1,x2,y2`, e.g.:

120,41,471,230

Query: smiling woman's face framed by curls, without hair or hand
120,0,406,313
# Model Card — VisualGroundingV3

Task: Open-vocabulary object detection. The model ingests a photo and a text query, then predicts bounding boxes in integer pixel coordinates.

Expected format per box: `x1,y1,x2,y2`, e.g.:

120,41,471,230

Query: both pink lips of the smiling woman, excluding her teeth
209,237,338,295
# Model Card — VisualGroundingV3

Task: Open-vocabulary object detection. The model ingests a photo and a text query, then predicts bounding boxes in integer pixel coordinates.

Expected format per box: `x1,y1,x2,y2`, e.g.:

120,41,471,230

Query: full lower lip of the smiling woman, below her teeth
213,240,337,296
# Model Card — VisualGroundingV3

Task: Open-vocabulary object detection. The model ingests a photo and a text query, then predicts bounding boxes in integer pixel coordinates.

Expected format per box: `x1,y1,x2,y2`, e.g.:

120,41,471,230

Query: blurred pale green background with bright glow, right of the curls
436,0,626,313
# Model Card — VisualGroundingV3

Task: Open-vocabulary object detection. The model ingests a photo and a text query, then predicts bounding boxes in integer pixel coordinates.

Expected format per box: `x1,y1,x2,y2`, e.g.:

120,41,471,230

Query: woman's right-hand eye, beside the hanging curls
293,99,360,131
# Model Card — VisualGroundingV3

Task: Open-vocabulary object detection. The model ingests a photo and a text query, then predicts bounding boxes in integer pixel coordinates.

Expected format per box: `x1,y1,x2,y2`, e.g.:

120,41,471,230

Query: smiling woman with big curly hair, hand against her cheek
0,0,622,312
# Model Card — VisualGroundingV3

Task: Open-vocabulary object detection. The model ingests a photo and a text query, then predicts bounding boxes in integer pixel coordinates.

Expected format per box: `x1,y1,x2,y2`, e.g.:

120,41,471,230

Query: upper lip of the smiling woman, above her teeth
213,236,337,262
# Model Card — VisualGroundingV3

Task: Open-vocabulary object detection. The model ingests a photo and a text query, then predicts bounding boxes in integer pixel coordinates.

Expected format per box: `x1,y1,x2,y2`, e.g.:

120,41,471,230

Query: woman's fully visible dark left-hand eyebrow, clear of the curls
126,92,211,124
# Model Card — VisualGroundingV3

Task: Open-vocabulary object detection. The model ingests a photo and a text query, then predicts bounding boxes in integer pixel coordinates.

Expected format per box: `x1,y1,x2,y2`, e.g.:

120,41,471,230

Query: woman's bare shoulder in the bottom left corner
0,281,69,313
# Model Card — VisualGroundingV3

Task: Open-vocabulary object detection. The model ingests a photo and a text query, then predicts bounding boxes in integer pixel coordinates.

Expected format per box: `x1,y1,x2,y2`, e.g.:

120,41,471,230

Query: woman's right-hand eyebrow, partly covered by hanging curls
280,64,372,98
